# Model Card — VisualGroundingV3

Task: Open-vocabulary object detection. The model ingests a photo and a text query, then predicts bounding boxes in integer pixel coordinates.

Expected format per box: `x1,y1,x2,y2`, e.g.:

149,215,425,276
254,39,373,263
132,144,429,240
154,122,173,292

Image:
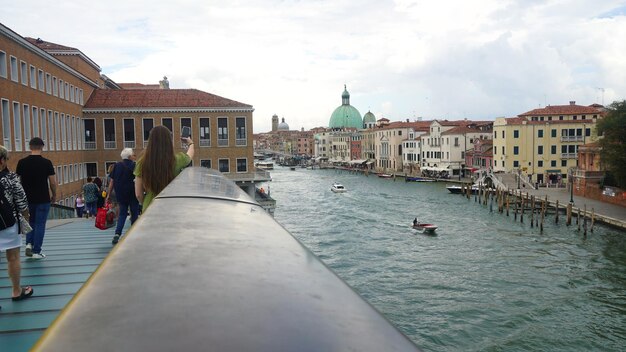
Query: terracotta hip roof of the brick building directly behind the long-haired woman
85,89,252,109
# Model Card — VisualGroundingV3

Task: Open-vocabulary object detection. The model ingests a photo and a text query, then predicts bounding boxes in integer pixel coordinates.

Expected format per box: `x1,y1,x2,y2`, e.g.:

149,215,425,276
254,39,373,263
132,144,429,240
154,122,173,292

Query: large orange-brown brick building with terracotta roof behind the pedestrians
0,24,267,206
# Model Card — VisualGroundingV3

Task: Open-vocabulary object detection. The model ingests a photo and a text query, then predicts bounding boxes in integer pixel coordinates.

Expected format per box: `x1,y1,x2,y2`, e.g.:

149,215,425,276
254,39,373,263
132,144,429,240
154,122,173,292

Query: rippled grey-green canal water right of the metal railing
269,167,626,351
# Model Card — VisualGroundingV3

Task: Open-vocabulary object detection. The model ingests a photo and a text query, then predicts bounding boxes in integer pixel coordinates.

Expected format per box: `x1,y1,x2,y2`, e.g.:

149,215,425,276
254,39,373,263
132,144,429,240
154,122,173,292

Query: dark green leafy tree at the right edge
596,100,626,188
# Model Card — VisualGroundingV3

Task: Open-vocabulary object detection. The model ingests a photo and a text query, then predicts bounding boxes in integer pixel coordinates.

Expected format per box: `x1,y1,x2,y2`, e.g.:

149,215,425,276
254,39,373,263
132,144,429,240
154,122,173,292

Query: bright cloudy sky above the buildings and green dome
0,0,626,133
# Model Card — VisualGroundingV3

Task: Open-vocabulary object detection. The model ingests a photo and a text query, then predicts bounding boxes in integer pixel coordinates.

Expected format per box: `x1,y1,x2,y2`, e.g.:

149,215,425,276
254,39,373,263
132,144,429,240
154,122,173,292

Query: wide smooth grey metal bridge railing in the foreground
34,167,417,351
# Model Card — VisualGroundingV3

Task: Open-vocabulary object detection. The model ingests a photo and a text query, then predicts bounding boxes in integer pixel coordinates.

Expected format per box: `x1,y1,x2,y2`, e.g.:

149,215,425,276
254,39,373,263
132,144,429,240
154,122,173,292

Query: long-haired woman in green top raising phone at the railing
135,126,194,212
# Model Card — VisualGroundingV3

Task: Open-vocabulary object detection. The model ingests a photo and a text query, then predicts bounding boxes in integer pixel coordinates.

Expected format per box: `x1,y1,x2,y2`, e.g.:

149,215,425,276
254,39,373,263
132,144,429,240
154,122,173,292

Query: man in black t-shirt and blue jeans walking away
15,137,57,259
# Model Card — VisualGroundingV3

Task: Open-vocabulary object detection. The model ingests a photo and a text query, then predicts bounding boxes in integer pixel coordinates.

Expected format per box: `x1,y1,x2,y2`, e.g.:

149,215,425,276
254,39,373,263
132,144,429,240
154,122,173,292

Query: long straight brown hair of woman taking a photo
141,126,175,195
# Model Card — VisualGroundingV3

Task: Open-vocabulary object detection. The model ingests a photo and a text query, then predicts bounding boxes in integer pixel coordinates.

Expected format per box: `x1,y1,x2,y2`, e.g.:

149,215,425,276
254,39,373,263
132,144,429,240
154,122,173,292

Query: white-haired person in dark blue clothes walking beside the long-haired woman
107,148,139,244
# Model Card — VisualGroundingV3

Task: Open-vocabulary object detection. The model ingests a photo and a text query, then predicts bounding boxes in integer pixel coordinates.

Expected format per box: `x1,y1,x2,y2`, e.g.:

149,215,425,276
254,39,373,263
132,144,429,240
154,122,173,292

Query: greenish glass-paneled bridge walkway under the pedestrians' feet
0,218,117,352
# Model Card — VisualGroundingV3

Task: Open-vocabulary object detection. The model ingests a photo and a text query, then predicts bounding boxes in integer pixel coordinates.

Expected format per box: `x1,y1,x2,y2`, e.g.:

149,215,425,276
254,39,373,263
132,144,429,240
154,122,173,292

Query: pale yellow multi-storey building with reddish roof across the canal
493,101,604,184
